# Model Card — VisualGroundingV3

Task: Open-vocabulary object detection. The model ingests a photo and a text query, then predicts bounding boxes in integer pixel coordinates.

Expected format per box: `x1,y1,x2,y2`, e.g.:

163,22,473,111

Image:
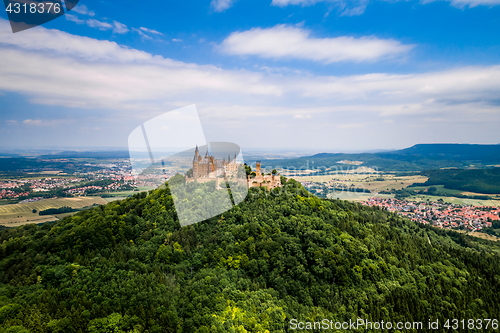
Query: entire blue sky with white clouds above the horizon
0,0,500,151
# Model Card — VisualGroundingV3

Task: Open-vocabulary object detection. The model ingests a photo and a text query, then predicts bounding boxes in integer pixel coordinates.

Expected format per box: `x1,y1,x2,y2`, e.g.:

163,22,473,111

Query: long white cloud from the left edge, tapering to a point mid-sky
0,20,281,109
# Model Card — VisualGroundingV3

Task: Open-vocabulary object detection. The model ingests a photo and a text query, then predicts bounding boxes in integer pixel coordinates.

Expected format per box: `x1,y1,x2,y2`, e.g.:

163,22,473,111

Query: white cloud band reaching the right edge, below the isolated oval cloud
294,66,500,105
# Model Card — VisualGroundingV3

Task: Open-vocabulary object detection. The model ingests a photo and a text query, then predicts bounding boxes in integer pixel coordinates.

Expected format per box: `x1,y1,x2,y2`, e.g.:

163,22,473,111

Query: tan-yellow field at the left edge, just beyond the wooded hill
0,197,107,227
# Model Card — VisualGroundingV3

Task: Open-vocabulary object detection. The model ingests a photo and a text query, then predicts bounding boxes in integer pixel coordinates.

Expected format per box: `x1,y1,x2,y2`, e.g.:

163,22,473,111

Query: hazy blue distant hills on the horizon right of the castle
262,144,500,171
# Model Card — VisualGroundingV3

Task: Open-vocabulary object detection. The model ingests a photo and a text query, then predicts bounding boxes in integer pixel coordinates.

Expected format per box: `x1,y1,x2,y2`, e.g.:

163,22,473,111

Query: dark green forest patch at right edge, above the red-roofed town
422,168,500,194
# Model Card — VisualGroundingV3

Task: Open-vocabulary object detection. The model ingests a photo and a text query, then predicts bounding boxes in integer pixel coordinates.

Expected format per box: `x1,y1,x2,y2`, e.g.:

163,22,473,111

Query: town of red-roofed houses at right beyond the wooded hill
363,197,500,230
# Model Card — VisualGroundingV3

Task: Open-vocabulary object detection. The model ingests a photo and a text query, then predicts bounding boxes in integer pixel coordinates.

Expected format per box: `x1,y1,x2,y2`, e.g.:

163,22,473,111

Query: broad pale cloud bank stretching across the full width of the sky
0,20,500,148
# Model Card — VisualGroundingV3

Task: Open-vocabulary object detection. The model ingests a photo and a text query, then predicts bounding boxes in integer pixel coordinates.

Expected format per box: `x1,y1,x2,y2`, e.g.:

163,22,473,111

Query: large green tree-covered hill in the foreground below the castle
0,180,500,333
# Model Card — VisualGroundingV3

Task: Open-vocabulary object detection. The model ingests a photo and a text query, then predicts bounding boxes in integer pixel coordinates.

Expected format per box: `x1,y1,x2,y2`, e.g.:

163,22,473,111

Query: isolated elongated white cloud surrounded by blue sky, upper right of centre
220,25,414,63
